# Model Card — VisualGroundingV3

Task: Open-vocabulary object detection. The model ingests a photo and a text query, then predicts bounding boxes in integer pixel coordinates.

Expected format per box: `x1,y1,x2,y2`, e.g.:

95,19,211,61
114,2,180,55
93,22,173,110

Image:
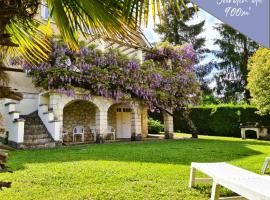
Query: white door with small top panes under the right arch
116,108,131,138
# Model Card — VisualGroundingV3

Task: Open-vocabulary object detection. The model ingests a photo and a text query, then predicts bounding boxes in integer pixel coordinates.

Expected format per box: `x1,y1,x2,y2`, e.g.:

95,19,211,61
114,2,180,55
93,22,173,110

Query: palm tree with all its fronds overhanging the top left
0,0,190,98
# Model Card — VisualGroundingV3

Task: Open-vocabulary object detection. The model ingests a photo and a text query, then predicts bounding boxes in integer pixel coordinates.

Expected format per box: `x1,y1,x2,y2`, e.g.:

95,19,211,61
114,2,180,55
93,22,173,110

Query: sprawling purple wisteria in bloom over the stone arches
24,41,200,109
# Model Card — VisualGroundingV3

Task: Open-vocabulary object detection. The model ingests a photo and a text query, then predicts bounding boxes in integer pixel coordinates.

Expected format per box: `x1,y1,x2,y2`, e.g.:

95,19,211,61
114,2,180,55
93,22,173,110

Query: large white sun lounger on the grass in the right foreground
189,163,270,200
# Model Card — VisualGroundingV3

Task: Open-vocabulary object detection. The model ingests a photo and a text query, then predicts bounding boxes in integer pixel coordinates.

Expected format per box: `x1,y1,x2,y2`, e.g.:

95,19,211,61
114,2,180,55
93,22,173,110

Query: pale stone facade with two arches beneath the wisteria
43,93,152,142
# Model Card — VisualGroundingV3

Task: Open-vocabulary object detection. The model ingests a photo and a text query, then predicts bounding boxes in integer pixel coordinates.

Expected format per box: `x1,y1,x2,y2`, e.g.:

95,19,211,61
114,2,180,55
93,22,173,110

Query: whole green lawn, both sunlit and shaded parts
0,136,270,200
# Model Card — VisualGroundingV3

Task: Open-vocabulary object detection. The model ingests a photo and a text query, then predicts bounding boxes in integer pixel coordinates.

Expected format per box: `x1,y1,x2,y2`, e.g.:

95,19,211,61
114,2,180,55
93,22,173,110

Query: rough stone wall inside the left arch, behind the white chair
63,101,96,142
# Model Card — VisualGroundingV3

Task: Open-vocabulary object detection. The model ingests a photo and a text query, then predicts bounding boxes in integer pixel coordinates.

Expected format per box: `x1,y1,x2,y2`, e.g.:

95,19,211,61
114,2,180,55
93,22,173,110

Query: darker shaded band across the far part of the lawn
6,139,269,170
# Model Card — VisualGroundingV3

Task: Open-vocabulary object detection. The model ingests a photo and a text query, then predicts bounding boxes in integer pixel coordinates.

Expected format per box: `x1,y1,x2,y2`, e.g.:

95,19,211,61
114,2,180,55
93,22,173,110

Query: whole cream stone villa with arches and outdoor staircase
0,5,173,149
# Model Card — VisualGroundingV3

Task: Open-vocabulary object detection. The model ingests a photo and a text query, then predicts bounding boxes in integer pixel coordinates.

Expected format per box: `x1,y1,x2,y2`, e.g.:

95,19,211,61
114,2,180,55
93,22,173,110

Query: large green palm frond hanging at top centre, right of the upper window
47,0,143,48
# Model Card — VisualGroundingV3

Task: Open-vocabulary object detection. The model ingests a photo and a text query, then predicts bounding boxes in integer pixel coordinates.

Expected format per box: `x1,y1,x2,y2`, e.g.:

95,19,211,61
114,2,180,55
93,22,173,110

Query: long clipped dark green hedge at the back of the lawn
149,105,270,137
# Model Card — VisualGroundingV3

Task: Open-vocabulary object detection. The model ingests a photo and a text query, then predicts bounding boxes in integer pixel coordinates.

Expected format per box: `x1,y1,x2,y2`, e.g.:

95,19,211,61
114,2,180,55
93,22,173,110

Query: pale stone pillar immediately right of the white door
131,105,142,140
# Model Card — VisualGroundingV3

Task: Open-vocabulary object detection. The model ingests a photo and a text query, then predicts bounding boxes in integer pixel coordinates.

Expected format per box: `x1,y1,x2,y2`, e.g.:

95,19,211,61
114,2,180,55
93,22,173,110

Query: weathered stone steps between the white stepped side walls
20,111,59,149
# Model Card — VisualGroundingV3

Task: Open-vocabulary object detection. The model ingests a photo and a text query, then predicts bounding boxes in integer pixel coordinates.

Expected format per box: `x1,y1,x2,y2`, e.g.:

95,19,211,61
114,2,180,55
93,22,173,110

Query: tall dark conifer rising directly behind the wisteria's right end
156,0,212,98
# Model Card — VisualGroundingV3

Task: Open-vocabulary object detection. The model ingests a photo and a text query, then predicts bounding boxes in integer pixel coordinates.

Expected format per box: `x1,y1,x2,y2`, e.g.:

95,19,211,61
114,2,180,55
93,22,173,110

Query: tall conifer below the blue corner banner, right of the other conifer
215,24,259,102
